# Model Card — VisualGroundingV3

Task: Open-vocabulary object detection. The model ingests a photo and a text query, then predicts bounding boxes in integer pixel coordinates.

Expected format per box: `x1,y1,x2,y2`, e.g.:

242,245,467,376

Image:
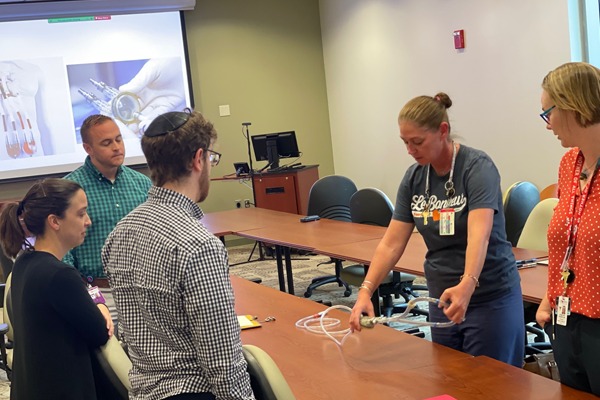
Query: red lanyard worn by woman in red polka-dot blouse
561,151,600,272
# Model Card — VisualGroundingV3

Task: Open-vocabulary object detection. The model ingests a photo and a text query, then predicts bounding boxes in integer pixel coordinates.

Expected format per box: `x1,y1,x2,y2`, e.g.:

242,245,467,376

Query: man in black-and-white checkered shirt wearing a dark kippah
102,111,254,400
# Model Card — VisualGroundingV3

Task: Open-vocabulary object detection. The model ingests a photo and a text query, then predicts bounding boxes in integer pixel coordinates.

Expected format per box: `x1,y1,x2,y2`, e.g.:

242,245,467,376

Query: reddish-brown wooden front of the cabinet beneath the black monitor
254,175,298,214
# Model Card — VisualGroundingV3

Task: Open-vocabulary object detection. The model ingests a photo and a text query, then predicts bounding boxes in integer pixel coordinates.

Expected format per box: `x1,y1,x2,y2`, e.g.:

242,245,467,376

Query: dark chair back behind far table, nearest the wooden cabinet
308,175,356,222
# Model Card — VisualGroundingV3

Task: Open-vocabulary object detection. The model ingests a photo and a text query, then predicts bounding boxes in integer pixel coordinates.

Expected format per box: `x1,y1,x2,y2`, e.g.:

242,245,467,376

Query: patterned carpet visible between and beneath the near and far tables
227,245,431,340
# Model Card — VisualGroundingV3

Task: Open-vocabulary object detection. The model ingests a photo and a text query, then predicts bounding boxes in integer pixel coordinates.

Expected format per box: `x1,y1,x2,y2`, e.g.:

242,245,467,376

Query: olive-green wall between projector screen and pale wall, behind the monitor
0,0,333,216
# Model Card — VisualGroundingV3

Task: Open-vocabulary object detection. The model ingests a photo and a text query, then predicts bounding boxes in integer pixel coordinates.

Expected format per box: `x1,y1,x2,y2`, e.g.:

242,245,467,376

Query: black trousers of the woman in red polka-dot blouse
544,313,600,396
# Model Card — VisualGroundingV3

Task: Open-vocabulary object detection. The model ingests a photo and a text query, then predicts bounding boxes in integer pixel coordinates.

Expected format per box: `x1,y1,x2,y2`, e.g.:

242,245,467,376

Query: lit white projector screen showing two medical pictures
0,12,192,180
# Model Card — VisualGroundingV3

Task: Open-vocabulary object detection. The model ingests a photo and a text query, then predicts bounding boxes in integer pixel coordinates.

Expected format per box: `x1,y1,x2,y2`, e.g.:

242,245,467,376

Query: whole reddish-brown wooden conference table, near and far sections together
203,209,596,400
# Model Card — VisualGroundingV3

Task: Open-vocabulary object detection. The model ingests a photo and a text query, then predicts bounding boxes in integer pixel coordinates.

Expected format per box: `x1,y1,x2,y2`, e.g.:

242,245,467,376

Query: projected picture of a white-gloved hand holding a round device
67,57,186,143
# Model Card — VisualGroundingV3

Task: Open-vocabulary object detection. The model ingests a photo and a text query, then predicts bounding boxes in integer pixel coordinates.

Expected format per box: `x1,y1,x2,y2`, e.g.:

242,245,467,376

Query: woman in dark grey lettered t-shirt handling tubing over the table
350,93,525,367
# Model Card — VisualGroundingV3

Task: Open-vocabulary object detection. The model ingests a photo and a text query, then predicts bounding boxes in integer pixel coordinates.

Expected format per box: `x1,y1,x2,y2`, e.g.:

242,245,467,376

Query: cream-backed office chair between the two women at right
517,198,558,355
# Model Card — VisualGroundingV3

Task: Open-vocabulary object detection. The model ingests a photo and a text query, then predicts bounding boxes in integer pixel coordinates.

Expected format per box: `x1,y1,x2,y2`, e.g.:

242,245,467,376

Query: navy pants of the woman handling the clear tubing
429,285,525,368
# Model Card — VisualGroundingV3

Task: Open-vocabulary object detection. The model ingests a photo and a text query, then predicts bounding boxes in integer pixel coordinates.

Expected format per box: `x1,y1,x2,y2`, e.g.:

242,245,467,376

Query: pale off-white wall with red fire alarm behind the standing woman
321,0,570,200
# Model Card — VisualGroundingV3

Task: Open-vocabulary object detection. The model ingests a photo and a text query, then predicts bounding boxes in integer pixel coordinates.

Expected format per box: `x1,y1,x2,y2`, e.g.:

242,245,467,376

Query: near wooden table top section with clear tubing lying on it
231,276,472,400
